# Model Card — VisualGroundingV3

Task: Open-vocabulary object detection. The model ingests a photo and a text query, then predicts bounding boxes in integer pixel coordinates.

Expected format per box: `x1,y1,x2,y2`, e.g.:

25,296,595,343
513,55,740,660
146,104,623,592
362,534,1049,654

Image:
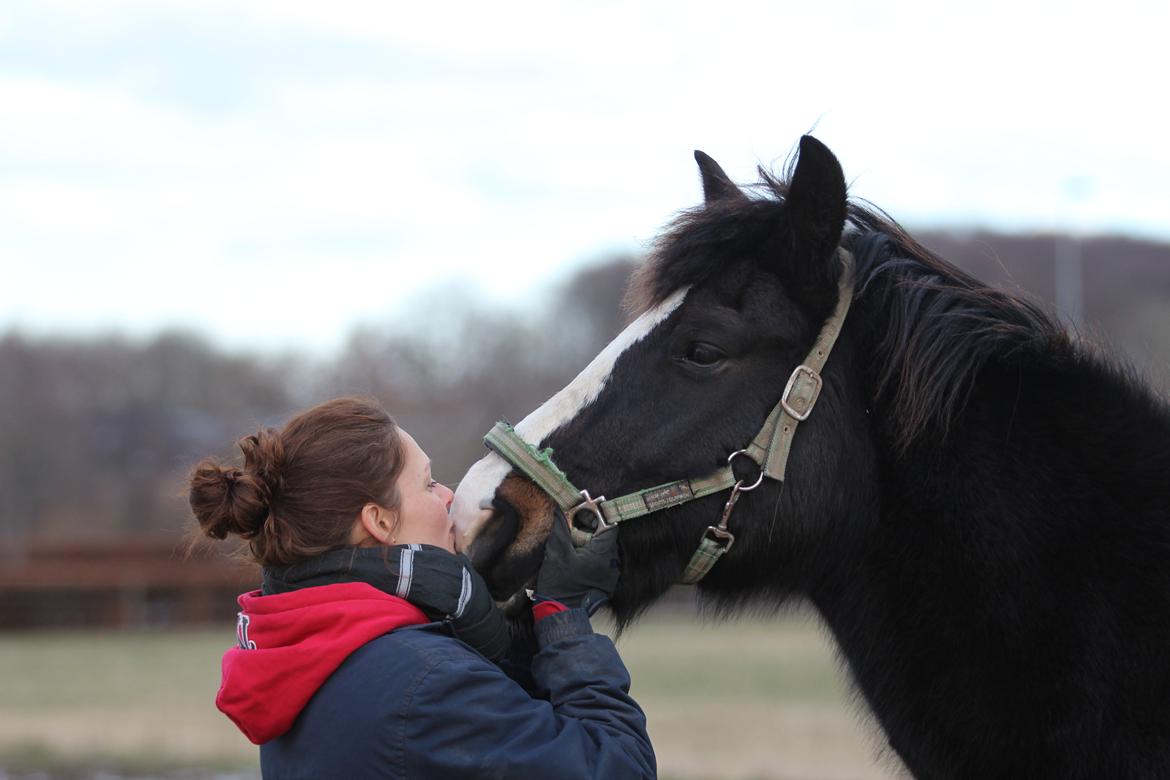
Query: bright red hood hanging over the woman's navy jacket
215,582,429,745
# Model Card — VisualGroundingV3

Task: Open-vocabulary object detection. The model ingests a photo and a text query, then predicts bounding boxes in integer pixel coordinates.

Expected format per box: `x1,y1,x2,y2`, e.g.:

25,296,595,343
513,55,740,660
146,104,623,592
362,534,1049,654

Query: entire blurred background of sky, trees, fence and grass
0,0,1170,779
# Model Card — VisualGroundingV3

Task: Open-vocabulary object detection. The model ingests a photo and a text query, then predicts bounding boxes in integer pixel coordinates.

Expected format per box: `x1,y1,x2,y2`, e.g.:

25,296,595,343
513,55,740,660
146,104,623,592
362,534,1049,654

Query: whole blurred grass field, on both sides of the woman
0,616,901,780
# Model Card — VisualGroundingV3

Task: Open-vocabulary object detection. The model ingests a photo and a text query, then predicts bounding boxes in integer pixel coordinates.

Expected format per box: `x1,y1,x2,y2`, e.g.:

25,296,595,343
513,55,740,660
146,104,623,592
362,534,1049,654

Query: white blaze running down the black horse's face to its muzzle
450,288,687,550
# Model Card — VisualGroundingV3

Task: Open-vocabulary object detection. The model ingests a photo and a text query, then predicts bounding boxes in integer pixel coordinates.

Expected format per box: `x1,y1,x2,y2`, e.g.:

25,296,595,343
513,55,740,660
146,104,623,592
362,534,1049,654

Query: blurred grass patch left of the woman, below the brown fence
0,626,257,772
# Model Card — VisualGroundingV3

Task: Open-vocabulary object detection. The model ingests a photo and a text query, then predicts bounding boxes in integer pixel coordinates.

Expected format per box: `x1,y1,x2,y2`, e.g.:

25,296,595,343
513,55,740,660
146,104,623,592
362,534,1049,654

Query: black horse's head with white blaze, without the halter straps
452,137,876,621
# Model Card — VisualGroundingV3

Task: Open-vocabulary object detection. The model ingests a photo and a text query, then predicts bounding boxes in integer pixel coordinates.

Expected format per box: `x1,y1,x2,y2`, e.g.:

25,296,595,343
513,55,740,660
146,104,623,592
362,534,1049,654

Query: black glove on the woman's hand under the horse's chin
536,517,621,615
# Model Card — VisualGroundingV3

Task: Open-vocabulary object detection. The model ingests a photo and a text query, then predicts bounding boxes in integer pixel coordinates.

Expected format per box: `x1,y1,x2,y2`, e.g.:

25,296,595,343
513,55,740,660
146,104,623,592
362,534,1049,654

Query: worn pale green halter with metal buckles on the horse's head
483,249,853,585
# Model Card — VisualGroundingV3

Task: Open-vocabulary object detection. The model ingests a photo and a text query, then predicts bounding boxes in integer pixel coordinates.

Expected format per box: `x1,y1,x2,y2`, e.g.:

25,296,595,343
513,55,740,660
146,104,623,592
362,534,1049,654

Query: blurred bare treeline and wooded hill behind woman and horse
0,233,1170,542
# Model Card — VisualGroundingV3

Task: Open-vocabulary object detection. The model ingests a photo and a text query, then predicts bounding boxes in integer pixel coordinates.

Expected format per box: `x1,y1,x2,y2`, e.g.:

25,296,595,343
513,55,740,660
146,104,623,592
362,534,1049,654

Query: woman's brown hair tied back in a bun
188,398,405,566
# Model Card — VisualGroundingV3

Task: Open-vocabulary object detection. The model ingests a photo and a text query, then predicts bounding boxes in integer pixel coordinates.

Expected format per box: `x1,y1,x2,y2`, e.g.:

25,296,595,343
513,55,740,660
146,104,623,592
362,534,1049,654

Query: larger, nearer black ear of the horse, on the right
783,136,846,295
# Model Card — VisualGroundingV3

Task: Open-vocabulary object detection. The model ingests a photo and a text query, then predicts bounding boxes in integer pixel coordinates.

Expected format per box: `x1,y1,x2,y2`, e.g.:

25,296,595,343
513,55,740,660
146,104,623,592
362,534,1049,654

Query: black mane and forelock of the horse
626,169,1072,451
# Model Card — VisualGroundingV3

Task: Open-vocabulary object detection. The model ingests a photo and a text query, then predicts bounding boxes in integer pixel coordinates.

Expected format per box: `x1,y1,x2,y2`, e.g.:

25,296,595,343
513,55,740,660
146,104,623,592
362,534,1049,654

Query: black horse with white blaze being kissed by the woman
452,136,1170,779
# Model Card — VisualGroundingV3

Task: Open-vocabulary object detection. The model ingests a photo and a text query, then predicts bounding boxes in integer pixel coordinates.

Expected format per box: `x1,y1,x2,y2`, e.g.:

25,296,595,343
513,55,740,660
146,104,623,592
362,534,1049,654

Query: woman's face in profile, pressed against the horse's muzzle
394,430,455,552
